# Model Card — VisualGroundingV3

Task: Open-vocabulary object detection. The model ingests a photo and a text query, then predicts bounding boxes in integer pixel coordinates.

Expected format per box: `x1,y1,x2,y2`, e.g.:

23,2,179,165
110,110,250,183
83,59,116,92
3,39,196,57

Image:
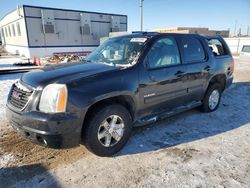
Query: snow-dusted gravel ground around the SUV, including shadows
0,56,250,188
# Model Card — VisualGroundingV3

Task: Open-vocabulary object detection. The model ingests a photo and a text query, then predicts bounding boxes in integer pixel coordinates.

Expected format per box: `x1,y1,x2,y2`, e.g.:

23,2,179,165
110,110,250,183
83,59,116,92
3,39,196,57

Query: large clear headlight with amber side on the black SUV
39,84,68,113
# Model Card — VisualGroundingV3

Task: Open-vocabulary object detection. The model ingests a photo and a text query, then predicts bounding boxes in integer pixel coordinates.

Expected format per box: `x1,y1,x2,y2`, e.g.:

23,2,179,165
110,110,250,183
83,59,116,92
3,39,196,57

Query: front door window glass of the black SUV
147,37,180,68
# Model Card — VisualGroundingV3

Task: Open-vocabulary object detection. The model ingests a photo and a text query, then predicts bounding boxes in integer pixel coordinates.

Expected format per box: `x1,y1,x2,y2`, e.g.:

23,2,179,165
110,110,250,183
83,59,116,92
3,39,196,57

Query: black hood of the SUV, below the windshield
21,63,118,87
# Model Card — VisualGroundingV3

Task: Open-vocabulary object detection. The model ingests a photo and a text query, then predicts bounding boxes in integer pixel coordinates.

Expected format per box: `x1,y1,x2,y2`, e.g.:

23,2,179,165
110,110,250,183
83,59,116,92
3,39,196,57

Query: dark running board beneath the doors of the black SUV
134,101,202,127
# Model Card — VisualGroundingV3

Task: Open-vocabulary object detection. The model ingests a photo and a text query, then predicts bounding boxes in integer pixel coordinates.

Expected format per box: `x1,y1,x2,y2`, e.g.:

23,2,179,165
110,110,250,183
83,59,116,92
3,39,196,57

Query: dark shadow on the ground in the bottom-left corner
0,164,61,187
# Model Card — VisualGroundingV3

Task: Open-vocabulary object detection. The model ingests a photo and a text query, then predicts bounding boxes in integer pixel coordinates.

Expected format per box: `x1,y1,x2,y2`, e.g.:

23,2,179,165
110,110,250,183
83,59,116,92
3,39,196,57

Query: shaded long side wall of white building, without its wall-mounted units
26,7,127,47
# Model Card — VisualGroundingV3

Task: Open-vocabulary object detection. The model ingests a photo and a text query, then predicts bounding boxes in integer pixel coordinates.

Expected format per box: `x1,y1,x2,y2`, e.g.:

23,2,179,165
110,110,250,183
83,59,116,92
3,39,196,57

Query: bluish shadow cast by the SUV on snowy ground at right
117,82,250,156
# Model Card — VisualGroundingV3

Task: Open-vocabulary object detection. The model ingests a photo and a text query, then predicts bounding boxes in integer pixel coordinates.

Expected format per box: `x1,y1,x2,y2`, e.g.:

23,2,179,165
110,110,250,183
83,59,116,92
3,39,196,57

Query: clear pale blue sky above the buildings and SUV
0,0,250,34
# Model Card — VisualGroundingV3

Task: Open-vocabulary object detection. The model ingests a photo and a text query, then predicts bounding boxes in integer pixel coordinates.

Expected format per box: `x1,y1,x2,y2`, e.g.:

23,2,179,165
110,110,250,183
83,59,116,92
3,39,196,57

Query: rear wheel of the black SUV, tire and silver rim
201,83,222,112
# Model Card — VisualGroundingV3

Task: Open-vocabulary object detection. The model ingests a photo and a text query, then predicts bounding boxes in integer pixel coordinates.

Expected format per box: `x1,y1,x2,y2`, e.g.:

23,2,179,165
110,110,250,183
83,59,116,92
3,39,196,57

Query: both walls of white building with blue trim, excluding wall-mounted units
0,5,127,58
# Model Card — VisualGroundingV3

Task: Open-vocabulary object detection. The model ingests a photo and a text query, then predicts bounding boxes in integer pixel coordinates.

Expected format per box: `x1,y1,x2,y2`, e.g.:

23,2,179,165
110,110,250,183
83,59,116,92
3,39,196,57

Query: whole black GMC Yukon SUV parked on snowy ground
7,32,234,156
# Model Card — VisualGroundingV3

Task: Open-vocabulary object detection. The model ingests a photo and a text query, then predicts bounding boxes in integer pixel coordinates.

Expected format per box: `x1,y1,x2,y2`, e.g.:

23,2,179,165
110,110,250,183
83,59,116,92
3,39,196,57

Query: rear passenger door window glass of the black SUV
181,37,206,63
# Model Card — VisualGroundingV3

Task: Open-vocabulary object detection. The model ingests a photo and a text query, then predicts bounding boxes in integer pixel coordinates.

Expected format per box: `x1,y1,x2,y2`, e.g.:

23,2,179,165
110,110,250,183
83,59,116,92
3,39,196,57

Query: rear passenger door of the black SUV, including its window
178,35,212,103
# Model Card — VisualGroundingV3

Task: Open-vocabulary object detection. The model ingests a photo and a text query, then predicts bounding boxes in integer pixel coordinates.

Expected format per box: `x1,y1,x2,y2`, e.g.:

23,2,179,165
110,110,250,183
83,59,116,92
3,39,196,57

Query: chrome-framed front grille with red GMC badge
8,82,33,110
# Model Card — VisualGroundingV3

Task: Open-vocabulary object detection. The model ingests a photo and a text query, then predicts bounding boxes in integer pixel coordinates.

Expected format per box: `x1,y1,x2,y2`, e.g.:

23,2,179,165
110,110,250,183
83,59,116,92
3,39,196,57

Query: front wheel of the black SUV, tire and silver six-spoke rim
83,104,132,156
